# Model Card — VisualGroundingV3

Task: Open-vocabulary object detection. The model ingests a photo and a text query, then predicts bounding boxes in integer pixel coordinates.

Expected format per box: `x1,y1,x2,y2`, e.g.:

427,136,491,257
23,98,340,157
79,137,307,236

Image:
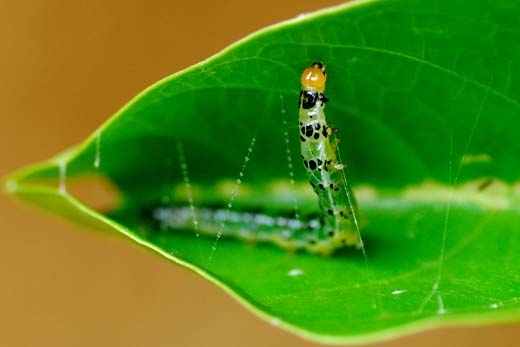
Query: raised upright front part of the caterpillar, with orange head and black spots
299,62,361,253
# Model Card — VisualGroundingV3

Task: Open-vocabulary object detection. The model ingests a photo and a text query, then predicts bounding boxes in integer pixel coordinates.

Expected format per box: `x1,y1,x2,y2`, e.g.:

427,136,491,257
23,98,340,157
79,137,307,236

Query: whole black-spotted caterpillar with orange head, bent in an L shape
146,62,361,255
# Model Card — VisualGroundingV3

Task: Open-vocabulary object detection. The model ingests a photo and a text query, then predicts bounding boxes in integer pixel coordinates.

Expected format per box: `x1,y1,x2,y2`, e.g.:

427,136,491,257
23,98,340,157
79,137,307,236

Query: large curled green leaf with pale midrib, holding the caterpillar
7,0,520,343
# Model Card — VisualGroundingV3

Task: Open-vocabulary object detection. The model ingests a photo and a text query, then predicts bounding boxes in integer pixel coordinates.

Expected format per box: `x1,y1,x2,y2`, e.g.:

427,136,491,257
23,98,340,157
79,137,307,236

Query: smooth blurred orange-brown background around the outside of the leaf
0,0,520,347
